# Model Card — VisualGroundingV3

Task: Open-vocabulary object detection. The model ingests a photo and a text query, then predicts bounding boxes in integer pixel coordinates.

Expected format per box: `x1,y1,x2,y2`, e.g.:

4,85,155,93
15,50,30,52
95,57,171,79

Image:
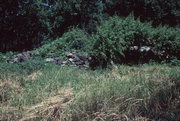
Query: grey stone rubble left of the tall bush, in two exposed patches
7,51,90,68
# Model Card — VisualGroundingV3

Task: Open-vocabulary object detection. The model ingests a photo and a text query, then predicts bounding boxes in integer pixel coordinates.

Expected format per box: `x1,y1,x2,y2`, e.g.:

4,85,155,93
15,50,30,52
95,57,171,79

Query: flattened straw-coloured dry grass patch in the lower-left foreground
20,89,73,121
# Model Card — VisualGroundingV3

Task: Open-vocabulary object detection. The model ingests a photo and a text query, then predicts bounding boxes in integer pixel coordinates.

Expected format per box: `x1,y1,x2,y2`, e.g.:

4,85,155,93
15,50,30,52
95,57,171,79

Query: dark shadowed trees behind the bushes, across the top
0,0,180,52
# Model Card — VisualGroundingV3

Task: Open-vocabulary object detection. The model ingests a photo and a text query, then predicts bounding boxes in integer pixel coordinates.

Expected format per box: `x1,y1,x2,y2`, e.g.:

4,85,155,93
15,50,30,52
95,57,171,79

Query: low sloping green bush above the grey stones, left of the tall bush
34,28,93,57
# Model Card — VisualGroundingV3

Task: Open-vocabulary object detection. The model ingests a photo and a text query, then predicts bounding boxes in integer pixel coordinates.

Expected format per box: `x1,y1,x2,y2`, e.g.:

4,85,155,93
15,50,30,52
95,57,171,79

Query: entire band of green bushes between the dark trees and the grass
34,15,180,67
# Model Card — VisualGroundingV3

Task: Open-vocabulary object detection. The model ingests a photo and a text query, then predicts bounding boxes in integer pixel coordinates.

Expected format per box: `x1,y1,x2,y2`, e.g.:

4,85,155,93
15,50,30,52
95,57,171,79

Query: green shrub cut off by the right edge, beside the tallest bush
149,26,180,60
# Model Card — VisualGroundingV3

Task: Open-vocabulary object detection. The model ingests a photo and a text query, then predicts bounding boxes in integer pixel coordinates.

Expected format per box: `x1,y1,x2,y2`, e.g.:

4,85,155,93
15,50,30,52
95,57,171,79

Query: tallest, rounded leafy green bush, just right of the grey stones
91,16,150,65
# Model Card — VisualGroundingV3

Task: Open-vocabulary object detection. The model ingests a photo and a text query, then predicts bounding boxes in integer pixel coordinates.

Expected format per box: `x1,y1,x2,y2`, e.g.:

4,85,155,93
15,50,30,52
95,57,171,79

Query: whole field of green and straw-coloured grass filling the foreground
0,62,180,121
